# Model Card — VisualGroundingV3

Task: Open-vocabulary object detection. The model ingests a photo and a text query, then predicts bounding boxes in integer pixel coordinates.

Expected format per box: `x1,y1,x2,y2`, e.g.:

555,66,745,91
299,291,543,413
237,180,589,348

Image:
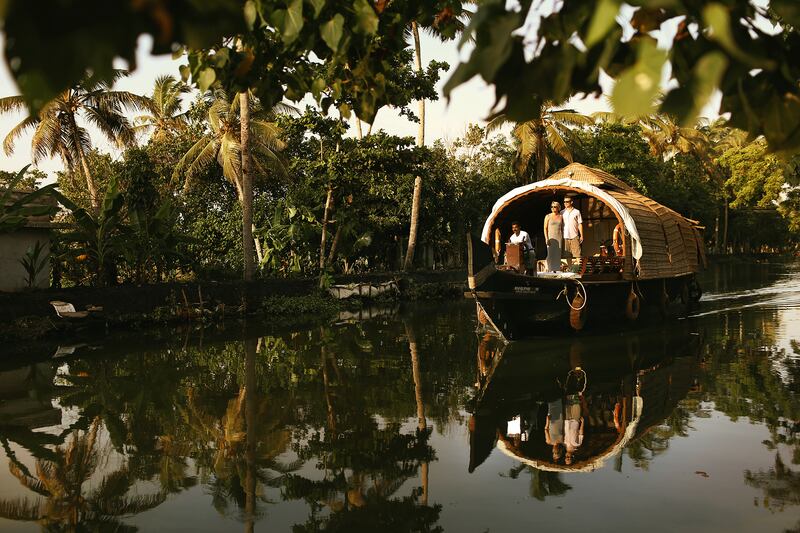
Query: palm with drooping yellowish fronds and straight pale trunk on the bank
173,89,293,280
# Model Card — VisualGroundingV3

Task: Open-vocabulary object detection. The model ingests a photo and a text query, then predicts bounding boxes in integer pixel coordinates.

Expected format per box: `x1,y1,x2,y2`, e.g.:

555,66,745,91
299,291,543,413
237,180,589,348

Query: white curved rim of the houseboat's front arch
481,178,642,260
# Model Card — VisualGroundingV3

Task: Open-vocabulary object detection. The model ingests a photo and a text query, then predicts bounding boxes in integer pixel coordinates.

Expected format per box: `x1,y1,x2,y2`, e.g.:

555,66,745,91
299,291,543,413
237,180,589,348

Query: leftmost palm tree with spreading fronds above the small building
0,70,152,210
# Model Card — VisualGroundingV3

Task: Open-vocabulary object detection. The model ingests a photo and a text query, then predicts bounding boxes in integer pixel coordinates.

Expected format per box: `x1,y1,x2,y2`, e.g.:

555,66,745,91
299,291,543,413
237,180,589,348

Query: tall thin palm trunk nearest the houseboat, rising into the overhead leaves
404,6,472,270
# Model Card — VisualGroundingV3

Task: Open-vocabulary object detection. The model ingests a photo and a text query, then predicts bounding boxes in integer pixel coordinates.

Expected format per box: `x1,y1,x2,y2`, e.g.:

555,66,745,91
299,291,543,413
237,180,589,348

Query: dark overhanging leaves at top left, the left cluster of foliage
0,0,463,122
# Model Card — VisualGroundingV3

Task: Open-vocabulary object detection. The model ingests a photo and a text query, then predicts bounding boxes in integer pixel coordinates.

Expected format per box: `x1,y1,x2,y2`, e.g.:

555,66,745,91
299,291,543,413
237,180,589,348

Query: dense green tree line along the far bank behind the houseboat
4,71,800,284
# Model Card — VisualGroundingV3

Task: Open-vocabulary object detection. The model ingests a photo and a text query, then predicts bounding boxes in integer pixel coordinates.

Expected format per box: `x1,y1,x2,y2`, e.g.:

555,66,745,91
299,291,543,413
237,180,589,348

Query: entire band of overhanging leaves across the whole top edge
6,0,800,152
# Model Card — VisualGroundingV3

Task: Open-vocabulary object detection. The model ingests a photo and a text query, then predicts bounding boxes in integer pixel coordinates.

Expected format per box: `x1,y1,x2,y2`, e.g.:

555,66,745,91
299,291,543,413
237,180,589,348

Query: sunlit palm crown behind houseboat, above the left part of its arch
486,102,593,181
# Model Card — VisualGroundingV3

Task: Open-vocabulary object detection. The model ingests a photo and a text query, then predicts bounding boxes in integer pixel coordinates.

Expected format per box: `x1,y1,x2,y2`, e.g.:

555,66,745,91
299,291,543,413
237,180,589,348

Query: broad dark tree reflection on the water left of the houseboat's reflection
0,310,471,531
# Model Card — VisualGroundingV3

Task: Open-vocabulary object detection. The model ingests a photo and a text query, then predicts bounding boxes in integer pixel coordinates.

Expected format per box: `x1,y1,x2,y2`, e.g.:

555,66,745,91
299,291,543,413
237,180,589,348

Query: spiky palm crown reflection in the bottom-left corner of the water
0,419,165,531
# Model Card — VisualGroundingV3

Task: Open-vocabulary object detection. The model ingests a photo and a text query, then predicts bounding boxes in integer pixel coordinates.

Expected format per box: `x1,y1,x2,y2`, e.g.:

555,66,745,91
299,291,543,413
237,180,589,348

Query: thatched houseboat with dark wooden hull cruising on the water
467,163,705,338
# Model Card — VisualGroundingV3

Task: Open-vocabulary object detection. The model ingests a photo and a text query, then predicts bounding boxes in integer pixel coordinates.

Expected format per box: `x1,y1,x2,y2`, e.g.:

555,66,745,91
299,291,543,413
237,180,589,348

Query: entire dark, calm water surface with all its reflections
0,263,800,532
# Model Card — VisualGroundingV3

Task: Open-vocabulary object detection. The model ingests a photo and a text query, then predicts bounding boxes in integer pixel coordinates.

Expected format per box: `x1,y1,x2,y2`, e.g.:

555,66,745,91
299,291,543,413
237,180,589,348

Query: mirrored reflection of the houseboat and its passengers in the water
469,333,701,472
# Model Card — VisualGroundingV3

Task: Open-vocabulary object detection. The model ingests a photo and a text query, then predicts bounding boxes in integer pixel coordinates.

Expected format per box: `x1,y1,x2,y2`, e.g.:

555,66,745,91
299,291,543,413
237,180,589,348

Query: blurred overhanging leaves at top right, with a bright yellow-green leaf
445,0,800,156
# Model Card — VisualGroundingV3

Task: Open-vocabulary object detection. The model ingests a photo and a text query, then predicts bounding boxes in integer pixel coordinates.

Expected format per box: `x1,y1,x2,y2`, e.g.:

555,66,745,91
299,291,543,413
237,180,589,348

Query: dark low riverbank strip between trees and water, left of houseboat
0,270,466,343
